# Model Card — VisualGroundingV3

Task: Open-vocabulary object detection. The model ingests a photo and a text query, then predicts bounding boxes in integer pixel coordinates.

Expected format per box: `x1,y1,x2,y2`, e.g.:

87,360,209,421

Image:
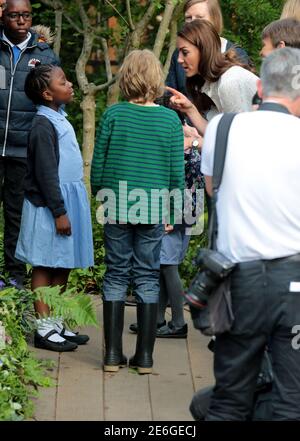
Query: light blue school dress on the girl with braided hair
15,106,94,269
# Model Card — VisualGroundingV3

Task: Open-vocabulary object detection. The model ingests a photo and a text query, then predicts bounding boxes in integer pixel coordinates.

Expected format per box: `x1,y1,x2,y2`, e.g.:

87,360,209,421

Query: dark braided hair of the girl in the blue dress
24,62,57,104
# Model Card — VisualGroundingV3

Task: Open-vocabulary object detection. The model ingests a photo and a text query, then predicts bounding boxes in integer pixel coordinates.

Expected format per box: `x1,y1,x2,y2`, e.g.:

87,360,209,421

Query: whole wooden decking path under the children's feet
33,299,214,421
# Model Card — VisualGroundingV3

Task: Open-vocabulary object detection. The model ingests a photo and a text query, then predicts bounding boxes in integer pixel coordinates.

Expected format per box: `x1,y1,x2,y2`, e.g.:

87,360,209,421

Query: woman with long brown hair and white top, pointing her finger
168,19,258,135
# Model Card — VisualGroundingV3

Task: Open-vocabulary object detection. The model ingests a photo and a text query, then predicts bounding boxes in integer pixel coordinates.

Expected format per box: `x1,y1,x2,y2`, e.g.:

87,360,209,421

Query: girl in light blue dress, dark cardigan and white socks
16,64,94,352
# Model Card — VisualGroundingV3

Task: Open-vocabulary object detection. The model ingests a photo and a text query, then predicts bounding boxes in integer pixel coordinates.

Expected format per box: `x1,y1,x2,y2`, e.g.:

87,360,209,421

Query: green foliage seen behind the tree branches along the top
28,0,284,141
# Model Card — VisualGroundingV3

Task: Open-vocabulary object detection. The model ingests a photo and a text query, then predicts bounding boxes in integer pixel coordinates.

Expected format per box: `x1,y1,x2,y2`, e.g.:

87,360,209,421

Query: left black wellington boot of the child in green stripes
103,300,127,372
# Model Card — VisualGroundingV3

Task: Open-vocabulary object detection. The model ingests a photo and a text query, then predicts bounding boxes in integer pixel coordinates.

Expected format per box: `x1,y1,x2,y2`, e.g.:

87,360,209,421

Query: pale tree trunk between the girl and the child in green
80,92,96,196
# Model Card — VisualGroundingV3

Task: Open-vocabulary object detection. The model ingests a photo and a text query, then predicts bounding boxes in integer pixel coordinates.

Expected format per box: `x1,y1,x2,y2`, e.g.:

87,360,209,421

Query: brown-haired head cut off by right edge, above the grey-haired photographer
260,18,300,58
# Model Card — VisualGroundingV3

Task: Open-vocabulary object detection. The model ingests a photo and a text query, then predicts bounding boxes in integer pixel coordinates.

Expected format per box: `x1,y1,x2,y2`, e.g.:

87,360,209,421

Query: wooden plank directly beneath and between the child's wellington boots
104,306,152,421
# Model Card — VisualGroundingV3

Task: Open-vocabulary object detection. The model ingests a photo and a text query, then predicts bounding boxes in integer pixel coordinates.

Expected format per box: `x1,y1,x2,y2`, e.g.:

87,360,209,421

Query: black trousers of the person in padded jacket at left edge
0,156,27,281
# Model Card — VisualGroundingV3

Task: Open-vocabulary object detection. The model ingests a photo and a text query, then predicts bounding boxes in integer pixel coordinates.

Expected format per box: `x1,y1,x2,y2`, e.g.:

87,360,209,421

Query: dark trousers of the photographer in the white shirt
206,254,300,421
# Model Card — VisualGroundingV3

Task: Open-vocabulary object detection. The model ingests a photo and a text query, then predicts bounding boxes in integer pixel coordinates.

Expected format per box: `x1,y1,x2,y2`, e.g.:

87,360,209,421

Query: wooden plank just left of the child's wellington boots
56,299,103,421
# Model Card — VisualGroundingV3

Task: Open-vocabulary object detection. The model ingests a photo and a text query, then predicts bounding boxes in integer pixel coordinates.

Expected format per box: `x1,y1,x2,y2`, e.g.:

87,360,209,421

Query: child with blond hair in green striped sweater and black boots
91,50,184,374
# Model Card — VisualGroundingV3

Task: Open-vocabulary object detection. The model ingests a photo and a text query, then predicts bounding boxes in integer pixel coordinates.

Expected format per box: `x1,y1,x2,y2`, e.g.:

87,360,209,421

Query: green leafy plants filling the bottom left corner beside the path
0,288,52,421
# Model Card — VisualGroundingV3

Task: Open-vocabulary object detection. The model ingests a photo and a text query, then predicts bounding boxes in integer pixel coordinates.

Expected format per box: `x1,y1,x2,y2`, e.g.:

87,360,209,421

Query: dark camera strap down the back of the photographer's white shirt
208,113,236,250
